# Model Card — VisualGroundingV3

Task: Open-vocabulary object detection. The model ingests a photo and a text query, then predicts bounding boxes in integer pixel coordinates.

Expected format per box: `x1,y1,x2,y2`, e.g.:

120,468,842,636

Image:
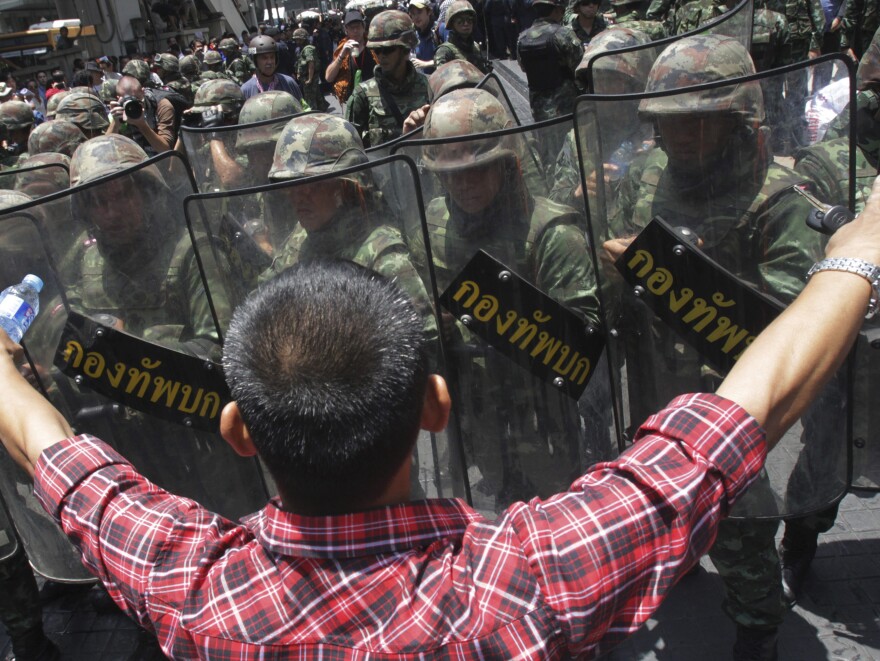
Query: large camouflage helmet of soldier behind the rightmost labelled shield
639,34,764,124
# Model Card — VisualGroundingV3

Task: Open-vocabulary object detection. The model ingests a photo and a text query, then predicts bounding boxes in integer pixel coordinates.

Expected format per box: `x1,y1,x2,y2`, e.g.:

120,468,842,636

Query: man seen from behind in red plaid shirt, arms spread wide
0,178,880,659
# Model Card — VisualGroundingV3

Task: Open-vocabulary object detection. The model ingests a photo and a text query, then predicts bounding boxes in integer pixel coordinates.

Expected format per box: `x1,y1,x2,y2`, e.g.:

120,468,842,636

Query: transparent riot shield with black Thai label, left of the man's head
0,152,267,580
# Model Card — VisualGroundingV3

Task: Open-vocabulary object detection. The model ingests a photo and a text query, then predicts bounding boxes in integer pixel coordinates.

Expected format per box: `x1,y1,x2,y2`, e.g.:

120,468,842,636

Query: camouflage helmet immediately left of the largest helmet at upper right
575,26,654,93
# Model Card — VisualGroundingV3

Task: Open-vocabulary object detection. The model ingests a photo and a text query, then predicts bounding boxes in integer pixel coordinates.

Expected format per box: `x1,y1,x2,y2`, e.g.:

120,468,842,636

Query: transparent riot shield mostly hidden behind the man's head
186,157,467,498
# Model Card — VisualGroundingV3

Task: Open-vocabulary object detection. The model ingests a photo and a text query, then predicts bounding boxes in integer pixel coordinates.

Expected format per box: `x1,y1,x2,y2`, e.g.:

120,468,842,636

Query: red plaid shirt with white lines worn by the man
36,395,766,659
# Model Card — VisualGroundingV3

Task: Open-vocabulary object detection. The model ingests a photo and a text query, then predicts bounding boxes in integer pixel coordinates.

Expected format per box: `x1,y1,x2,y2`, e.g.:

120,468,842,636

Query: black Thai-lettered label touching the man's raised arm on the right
615,217,784,372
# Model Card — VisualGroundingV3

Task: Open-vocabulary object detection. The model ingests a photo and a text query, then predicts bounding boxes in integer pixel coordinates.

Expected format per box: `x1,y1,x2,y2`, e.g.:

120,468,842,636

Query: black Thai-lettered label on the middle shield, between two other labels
440,250,605,399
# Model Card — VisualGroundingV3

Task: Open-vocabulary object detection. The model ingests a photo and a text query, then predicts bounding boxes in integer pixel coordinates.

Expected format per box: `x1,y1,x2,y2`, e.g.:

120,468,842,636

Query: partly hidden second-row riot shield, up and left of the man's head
180,113,310,193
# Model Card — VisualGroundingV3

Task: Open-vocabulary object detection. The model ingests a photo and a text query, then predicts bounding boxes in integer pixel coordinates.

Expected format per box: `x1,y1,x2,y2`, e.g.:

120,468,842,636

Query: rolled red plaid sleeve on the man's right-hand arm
508,394,767,657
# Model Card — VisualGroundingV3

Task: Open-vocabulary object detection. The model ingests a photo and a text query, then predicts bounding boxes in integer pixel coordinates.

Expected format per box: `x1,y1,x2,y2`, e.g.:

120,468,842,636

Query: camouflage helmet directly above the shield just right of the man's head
422,89,520,172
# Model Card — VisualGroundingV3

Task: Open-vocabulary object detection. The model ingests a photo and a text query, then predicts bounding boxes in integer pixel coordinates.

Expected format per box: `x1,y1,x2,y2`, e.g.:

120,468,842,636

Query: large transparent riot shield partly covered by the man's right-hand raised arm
575,56,852,517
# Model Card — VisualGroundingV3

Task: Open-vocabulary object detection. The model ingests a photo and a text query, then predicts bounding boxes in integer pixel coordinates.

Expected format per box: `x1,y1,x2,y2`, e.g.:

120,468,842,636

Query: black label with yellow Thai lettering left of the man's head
55,312,231,432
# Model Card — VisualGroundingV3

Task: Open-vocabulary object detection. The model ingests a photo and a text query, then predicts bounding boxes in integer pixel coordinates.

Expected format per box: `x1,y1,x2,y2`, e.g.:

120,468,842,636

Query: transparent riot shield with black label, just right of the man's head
398,118,617,511
